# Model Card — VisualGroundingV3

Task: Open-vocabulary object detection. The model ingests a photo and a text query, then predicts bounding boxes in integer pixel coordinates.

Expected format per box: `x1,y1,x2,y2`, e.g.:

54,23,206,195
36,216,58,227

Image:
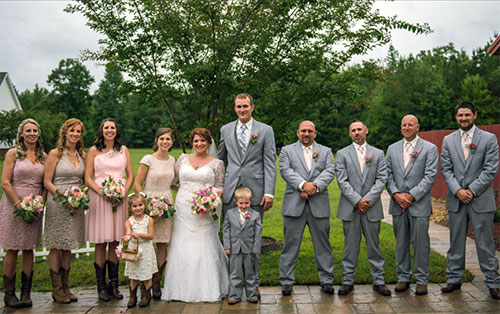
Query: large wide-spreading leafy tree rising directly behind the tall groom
67,0,430,150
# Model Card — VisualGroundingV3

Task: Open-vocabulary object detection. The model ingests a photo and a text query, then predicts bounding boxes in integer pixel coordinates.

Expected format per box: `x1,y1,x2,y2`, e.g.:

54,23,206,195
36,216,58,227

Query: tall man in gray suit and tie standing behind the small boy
217,93,276,296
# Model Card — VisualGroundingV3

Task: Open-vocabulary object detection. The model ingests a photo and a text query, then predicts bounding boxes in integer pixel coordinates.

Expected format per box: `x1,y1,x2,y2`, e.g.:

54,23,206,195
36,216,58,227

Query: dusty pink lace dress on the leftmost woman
0,158,45,250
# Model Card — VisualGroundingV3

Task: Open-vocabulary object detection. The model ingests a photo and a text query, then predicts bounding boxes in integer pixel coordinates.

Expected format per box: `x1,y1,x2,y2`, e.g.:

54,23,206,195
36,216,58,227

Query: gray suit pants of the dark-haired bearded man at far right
446,204,500,288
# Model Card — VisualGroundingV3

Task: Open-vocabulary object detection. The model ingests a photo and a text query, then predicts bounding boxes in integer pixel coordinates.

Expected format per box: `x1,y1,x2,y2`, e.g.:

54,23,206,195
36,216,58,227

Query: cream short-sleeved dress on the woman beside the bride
140,155,175,243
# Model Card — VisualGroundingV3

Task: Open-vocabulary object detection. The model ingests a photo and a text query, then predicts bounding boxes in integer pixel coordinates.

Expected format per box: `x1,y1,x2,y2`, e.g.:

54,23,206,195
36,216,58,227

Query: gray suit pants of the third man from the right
342,213,385,285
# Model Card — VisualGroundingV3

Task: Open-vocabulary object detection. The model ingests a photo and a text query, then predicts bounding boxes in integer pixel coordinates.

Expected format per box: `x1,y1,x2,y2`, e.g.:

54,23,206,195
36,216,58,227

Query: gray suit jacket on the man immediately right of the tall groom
279,141,335,218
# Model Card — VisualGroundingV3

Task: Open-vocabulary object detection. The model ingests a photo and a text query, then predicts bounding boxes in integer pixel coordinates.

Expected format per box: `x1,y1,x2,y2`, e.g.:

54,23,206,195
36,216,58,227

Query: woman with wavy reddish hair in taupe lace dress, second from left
43,118,85,303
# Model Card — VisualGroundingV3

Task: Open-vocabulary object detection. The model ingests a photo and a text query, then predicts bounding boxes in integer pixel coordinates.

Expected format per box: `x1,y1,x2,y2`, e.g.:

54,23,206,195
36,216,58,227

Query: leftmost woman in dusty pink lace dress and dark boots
0,119,47,308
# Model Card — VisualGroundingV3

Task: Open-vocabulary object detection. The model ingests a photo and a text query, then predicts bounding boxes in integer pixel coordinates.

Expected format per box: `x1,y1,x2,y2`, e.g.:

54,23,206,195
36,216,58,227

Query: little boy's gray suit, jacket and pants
223,207,262,301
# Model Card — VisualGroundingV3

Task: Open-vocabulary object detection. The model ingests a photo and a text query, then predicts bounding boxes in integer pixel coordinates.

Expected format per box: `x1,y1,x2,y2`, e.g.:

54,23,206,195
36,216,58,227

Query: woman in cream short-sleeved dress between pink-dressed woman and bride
134,128,177,299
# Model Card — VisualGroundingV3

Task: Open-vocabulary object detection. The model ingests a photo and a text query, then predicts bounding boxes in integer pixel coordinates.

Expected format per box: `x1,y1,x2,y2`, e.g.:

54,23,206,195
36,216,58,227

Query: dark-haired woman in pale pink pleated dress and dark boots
85,118,134,301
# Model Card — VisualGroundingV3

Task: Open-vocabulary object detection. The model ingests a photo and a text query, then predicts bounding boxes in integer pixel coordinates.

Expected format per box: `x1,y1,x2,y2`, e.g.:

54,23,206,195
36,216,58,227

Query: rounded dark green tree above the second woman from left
47,58,94,122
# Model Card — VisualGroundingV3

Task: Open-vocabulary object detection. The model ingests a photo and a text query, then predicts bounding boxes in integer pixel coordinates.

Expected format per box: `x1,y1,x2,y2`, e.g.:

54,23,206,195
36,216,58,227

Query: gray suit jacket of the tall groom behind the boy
218,119,276,206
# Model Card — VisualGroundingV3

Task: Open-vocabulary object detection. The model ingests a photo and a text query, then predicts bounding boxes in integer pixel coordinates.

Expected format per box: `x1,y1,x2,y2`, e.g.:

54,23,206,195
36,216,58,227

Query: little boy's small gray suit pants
228,253,259,301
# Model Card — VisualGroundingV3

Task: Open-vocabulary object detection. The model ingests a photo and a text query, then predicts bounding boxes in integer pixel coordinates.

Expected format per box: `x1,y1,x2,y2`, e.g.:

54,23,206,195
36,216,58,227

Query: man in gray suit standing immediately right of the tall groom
279,121,335,295
